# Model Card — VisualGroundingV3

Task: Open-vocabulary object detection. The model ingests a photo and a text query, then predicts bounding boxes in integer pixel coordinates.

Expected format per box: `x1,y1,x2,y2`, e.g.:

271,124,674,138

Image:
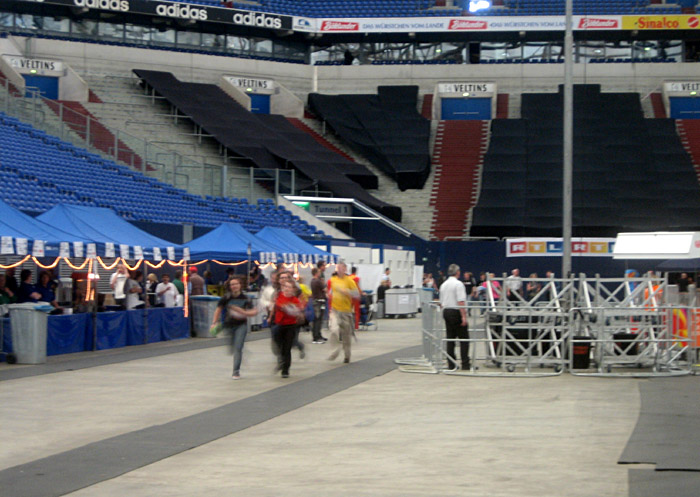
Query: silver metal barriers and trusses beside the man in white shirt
396,275,700,377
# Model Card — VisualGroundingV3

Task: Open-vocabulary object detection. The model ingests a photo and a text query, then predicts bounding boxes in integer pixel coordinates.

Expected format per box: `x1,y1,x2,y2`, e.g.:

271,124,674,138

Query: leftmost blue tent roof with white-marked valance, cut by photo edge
0,200,84,256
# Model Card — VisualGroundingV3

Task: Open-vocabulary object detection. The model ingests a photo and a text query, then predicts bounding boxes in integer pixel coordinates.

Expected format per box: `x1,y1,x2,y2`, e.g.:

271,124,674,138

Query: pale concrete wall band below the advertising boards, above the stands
16,34,700,102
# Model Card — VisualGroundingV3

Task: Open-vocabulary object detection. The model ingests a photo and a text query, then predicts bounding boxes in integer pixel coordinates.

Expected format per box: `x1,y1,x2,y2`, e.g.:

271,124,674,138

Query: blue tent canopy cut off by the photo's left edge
0,200,80,256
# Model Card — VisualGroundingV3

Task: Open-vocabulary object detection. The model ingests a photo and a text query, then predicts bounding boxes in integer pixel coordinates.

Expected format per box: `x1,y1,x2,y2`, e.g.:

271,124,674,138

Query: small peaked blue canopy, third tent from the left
185,223,288,262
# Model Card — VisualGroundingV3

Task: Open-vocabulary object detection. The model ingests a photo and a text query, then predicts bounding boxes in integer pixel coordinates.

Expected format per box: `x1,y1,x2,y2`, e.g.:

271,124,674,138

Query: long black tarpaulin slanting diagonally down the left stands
133,69,401,221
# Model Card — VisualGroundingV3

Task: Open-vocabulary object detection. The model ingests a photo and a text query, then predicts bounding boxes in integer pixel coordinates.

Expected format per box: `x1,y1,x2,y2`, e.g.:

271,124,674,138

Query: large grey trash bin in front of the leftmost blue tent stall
9,302,53,364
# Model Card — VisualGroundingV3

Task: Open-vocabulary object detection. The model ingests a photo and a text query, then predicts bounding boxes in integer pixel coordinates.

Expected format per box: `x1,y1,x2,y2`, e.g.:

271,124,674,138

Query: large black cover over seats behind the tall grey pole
471,85,700,237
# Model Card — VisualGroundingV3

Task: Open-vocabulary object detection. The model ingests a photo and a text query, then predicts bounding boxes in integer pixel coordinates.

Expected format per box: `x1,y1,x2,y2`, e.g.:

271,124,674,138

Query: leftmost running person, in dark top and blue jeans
211,276,258,380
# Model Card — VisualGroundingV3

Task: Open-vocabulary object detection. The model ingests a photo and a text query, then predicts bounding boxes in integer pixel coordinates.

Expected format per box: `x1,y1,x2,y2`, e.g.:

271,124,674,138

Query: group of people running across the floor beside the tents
211,261,361,380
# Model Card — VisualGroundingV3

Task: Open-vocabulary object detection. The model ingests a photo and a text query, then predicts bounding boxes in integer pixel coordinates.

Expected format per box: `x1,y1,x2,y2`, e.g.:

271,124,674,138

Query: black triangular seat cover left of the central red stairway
309,86,430,190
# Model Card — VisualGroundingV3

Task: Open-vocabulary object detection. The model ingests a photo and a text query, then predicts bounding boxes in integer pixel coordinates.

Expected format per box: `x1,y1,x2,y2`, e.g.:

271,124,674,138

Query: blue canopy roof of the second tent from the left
37,204,183,260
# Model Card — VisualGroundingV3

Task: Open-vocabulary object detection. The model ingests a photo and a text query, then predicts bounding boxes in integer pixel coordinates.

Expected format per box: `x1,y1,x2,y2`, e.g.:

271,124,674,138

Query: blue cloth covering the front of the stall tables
0,307,190,356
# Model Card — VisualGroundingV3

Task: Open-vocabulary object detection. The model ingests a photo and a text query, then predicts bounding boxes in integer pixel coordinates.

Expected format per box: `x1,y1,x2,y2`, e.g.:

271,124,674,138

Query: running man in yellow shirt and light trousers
328,262,360,363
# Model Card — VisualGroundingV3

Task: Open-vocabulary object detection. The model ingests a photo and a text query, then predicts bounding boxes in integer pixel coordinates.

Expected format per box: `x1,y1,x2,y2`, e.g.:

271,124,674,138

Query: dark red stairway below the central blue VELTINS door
430,121,488,240
